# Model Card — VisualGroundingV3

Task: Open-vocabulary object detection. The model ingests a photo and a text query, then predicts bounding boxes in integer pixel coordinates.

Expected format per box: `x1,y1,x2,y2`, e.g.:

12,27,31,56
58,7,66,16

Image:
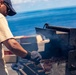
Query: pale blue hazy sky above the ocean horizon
11,0,76,12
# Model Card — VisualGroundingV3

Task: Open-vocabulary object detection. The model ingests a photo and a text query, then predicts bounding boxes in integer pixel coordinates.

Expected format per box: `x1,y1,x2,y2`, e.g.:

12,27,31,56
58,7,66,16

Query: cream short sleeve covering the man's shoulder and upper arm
0,14,13,42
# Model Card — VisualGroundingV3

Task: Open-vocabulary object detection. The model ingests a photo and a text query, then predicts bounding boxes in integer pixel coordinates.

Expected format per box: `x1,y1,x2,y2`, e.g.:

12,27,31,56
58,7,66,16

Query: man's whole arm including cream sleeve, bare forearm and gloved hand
0,14,41,62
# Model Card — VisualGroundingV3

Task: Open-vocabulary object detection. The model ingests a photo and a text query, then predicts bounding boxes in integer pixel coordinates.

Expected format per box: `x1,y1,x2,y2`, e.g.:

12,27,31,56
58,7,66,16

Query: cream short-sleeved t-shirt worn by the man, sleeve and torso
0,13,13,75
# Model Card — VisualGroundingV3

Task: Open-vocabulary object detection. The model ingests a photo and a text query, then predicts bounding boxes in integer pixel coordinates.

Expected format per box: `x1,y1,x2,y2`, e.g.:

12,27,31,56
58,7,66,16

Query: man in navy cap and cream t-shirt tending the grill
0,0,42,75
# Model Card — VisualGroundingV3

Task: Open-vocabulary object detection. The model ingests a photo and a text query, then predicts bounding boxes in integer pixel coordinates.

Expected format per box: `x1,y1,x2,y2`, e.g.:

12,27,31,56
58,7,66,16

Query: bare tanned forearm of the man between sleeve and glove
3,39,28,58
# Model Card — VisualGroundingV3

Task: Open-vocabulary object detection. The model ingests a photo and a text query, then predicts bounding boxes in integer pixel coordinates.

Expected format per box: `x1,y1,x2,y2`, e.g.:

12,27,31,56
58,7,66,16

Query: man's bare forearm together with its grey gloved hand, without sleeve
2,38,42,64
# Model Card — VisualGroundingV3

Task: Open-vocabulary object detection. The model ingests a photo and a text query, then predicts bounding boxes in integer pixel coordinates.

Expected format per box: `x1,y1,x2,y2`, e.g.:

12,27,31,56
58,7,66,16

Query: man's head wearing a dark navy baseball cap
0,0,16,16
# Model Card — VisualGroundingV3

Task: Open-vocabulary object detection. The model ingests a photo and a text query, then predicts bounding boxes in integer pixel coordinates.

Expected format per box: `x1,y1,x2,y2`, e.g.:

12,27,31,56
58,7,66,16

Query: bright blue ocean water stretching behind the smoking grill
7,7,76,36
